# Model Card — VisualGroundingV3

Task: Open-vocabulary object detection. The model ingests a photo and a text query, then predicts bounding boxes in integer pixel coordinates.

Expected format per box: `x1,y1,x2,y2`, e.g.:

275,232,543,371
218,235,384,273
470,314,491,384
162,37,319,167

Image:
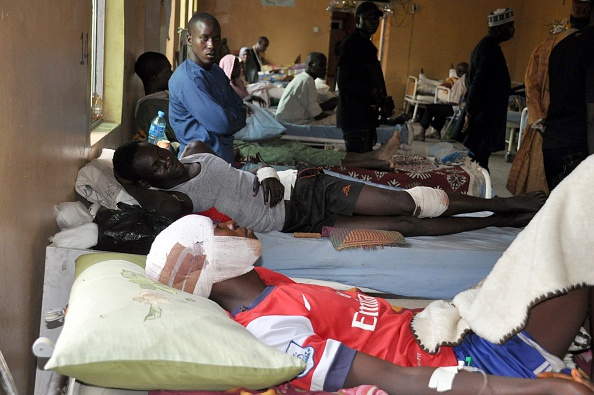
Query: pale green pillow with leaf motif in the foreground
45,254,304,390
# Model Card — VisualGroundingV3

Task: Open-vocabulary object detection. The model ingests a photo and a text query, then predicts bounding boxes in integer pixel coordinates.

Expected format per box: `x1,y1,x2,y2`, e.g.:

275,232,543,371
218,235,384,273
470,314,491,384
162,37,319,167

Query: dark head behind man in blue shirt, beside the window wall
134,52,173,95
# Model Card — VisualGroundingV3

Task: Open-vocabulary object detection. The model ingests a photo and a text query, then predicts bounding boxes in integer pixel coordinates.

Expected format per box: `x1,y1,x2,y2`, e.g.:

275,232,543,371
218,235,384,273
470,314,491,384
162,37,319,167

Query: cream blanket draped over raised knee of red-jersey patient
411,155,594,352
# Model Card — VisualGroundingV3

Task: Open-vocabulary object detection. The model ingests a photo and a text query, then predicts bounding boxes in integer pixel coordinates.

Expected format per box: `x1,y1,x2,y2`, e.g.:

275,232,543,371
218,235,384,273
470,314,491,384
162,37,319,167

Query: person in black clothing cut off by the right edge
542,1,594,190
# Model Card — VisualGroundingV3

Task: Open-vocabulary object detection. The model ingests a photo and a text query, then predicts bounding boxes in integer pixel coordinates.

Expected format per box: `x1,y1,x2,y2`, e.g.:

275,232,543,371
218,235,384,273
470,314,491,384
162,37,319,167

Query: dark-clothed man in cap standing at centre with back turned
337,1,387,152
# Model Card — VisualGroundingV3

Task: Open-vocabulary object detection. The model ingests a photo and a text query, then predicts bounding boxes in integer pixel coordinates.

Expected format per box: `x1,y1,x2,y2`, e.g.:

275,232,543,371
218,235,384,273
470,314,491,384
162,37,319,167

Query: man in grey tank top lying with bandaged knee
113,141,546,236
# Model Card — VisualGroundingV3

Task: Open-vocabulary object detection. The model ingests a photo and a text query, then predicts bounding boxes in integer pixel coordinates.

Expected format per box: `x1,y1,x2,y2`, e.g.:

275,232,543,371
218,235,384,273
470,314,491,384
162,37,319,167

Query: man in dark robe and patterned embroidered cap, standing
463,8,515,170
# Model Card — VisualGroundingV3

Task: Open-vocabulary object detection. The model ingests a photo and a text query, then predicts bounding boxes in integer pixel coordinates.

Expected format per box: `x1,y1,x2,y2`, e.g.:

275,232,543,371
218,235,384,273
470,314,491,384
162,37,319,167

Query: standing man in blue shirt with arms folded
169,13,246,163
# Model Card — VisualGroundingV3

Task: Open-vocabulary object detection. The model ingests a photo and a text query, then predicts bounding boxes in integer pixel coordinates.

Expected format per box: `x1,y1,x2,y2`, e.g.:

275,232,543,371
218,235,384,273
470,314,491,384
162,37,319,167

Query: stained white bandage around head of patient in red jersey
145,215,262,297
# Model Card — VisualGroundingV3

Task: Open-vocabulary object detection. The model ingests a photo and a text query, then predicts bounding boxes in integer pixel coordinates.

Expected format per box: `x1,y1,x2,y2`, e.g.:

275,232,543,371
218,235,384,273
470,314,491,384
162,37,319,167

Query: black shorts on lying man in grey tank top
282,172,364,233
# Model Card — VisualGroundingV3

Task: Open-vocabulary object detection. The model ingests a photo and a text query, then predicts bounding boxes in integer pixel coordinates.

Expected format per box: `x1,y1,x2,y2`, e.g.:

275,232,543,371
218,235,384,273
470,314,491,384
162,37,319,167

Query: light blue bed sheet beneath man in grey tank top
257,223,520,299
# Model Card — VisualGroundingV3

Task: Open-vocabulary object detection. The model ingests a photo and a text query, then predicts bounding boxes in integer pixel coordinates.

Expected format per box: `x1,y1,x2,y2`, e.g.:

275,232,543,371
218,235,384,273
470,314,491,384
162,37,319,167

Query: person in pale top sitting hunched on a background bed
275,52,337,125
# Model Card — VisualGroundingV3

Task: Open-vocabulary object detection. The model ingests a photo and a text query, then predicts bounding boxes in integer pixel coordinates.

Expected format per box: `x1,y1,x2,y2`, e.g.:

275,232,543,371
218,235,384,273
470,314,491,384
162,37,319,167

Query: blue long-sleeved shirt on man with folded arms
169,59,246,163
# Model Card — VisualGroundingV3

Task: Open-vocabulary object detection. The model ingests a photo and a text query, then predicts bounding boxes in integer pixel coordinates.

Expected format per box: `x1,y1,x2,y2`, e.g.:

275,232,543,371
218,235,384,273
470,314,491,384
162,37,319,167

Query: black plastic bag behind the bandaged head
95,202,173,255
